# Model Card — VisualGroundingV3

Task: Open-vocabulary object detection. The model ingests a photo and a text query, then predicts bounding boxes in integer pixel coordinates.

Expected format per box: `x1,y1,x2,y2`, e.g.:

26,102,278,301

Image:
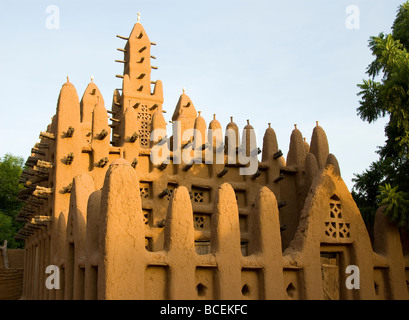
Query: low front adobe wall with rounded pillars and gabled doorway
17,160,409,299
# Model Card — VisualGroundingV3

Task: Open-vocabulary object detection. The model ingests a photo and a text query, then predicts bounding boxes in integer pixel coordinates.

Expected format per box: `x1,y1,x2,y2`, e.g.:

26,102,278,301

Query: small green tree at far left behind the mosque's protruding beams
0,154,24,248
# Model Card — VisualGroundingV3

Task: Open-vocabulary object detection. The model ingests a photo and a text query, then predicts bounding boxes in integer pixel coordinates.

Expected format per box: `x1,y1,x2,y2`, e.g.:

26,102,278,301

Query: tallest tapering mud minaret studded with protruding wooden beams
111,13,163,149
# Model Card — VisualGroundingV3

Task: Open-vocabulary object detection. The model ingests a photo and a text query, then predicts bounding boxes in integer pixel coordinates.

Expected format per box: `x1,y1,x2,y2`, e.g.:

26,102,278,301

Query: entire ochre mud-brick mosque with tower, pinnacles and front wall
17,15,409,300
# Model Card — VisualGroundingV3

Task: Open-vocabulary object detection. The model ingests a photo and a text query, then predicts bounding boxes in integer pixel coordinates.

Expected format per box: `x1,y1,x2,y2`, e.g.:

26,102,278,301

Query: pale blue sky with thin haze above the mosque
0,0,404,188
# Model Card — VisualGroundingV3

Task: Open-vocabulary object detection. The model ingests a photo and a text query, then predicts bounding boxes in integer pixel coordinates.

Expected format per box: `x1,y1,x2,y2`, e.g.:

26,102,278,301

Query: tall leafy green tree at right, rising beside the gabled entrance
352,1,409,228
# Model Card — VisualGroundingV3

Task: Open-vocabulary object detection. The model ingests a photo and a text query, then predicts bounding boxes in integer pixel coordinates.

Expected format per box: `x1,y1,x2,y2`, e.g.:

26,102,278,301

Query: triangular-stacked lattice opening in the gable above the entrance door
325,196,351,240
